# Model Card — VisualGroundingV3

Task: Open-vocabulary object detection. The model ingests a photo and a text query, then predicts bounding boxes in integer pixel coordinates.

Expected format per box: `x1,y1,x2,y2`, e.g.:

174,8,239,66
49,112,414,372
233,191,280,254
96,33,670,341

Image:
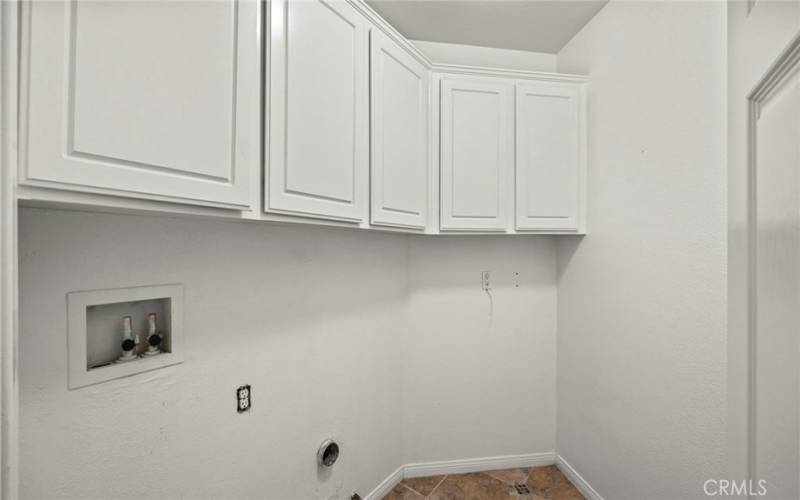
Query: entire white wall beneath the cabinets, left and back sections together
20,209,556,499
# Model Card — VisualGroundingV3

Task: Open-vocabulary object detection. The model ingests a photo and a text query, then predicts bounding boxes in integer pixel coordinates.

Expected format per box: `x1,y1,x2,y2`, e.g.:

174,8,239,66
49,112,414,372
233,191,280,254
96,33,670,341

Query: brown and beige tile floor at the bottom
383,465,583,500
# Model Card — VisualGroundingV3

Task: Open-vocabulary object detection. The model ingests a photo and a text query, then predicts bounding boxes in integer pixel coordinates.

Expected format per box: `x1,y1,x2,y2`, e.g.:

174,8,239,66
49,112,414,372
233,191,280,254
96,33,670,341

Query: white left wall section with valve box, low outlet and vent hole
20,209,407,499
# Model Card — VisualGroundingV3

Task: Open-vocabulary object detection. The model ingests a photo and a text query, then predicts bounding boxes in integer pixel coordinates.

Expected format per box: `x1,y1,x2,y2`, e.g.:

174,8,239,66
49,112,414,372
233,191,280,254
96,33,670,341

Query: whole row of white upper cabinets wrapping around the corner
12,0,586,234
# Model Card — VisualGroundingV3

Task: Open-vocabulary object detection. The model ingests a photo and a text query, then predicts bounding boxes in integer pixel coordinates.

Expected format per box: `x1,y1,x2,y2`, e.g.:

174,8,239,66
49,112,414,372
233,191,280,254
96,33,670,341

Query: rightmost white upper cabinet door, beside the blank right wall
516,83,585,232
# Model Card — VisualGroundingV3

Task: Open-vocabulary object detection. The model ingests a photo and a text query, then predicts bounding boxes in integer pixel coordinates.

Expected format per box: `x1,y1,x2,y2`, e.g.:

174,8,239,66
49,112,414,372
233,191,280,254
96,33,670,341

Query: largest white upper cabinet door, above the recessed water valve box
20,0,259,209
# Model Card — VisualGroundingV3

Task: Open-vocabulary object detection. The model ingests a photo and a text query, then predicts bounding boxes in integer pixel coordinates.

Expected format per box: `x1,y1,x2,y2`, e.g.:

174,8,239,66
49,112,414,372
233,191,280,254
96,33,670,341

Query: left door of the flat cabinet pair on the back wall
440,78,514,231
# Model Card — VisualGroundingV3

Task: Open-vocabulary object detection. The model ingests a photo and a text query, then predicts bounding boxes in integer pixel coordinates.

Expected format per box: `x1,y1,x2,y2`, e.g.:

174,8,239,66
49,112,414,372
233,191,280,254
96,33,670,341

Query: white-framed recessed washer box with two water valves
67,285,183,389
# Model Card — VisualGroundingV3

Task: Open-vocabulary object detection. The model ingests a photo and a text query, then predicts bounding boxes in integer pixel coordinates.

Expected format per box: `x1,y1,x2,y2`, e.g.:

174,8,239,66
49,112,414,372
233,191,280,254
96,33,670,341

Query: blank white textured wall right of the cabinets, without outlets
557,1,727,500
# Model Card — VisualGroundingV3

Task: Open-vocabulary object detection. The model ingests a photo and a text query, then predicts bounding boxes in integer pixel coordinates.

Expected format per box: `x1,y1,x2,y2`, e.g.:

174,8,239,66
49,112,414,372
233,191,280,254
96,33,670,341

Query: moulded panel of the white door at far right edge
751,38,800,499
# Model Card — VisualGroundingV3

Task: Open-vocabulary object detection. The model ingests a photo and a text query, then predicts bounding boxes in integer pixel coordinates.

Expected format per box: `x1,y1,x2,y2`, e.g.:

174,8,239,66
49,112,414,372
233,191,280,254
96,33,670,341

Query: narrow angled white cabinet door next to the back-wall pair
371,30,428,229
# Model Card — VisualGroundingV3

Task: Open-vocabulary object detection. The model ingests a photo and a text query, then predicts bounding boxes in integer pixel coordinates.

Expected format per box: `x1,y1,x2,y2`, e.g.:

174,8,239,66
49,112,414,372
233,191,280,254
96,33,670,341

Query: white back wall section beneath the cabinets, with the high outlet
403,236,556,462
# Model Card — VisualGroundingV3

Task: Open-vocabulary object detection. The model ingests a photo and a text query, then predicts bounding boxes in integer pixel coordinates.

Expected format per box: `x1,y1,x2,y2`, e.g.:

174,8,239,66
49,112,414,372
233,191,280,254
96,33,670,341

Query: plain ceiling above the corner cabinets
367,0,608,54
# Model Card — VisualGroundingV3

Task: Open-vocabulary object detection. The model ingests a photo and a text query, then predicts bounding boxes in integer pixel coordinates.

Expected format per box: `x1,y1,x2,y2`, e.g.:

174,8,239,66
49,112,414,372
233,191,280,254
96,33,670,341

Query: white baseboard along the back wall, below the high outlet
403,451,556,477
